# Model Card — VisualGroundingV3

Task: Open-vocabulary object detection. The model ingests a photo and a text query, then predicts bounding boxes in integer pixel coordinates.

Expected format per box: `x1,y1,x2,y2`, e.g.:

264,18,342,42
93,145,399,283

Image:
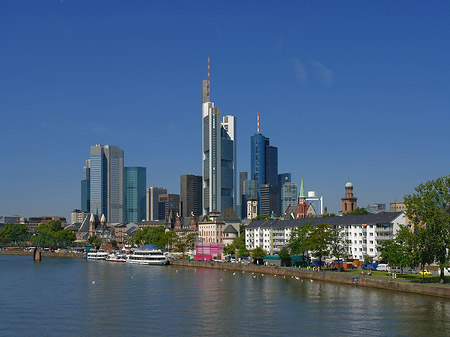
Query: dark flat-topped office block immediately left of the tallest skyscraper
180,174,202,217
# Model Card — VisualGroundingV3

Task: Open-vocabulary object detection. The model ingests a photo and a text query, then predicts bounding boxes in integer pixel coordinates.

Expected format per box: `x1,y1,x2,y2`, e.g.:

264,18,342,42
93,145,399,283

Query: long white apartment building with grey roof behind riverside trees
245,212,405,260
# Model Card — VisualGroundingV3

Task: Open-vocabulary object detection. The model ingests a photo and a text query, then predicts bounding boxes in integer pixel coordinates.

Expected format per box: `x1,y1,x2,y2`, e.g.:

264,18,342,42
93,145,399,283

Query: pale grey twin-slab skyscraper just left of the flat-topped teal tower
90,144,124,223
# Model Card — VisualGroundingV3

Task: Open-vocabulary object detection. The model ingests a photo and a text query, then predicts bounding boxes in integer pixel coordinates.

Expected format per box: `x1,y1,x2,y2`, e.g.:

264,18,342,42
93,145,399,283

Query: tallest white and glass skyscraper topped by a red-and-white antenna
202,58,237,215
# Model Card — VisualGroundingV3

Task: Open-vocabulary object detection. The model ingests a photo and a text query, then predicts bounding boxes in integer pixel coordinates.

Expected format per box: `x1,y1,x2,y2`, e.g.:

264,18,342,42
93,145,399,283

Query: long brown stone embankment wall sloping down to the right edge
171,260,450,298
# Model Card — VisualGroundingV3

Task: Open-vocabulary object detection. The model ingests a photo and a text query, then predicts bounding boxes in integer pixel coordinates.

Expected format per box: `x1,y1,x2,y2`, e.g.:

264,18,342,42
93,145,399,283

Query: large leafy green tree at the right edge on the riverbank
404,176,450,283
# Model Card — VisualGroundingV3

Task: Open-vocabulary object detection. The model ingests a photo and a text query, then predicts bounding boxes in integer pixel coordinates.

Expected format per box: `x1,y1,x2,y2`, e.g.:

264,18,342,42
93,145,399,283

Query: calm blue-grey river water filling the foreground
0,255,450,336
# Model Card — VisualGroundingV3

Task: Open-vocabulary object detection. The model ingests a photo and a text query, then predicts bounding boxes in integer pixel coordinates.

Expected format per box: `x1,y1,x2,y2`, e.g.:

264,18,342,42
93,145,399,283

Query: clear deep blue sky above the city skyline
0,0,450,216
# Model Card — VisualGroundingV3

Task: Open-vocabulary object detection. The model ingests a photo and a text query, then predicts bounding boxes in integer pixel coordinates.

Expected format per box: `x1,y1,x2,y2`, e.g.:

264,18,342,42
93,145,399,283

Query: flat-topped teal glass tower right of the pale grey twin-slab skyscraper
124,167,147,222
